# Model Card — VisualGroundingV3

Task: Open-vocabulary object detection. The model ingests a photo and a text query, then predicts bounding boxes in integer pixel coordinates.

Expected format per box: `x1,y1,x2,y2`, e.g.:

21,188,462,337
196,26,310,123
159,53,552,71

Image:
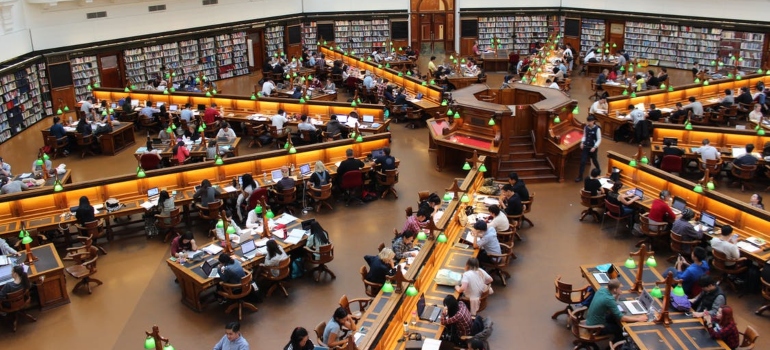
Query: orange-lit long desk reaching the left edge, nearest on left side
0,133,390,238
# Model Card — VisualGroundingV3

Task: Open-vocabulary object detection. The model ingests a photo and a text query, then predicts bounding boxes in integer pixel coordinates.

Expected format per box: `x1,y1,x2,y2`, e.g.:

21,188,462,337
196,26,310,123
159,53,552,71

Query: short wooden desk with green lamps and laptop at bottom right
580,262,729,350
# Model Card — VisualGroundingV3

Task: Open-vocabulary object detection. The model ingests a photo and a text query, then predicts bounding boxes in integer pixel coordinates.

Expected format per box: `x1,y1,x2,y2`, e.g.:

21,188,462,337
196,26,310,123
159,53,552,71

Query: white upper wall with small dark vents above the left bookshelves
26,0,302,50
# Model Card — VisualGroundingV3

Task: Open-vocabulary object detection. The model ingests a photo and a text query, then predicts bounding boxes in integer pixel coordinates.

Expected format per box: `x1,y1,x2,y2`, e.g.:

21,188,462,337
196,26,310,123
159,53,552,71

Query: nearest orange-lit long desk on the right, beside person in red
607,151,770,265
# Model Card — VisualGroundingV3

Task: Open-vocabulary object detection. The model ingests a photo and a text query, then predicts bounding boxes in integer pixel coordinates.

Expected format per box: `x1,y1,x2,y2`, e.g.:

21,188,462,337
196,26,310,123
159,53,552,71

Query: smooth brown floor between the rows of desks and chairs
0,56,770,350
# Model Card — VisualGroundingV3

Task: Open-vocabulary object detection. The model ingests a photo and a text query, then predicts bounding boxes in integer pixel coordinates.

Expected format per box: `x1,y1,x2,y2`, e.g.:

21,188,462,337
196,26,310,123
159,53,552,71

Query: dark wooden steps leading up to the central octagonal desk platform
497,135,559,183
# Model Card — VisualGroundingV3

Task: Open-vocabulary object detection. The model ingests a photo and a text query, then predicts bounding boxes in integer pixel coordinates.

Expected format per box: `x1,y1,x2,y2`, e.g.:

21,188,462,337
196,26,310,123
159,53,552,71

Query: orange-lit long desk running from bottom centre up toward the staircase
357,159,484,350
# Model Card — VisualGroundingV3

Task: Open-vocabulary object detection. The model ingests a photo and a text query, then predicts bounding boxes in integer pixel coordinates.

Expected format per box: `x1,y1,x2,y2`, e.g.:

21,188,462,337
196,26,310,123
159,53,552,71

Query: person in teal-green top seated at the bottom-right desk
586,278,647,342
